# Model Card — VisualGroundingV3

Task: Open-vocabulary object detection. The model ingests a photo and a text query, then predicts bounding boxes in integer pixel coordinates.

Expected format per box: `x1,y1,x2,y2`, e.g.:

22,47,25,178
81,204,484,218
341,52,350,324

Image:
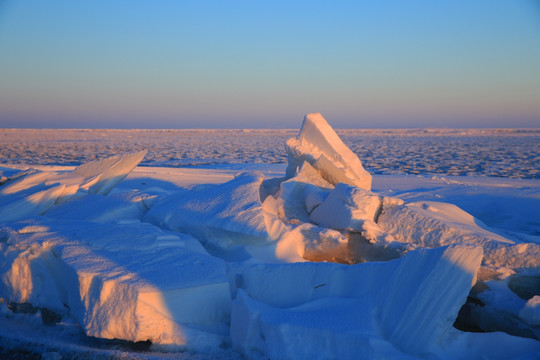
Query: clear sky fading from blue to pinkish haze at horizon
0,0,540,128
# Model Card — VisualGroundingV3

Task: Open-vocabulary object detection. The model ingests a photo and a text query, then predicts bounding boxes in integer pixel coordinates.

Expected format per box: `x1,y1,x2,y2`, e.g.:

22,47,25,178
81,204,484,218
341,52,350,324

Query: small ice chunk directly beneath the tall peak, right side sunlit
309,183,382,231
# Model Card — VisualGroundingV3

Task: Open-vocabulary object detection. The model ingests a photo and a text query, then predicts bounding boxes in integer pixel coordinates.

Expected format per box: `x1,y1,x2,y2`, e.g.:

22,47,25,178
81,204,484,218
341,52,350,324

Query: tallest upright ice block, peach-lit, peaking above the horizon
285,113,371,190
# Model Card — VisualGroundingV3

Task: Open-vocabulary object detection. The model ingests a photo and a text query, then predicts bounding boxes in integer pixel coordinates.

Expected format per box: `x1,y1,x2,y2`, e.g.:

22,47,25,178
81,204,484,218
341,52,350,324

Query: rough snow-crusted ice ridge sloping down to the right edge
378,201,540,272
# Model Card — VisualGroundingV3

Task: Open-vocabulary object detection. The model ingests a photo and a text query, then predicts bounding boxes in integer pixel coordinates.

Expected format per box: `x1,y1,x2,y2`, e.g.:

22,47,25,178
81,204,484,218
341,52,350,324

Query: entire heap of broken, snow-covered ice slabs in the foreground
0,114,540,359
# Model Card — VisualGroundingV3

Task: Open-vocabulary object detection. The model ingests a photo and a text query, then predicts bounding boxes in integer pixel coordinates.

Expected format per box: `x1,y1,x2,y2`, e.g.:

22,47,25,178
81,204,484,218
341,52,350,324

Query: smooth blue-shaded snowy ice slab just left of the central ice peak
144,173,274,250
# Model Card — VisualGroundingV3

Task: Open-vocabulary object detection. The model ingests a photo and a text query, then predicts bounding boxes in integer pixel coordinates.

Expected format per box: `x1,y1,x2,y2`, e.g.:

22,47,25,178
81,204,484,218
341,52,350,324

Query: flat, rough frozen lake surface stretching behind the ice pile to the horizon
0,129,540,179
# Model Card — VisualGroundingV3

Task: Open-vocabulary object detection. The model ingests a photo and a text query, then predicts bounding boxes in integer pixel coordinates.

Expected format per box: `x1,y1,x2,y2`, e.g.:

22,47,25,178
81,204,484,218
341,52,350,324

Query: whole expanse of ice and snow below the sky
0,114,540,359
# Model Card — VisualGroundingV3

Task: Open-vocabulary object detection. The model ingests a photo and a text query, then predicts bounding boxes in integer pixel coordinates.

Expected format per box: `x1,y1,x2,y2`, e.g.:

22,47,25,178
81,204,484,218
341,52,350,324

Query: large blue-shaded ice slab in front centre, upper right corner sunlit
230,246,482,359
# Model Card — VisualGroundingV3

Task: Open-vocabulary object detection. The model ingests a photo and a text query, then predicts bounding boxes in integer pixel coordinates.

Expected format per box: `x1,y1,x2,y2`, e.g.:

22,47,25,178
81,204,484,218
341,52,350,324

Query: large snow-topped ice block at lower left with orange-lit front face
0,218,230,348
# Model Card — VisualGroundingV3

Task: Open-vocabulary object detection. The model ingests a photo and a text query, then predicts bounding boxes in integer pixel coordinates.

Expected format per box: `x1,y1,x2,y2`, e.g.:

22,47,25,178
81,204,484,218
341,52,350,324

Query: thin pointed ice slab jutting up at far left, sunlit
73,150,147,195
